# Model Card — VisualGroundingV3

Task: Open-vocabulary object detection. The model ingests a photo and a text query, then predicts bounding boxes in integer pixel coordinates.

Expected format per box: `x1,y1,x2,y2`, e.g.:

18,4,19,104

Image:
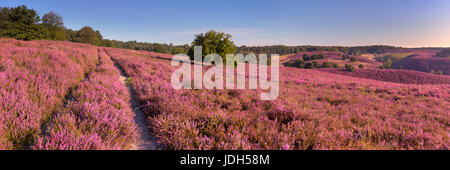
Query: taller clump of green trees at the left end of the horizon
0,5,102,45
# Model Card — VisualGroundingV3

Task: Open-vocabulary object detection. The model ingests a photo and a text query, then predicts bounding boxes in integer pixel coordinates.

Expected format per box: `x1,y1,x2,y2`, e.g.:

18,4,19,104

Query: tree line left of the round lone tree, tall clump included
0,5,190,54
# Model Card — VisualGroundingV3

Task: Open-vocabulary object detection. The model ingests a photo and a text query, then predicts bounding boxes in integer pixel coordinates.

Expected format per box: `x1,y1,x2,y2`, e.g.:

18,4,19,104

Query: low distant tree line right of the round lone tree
237,45,396,55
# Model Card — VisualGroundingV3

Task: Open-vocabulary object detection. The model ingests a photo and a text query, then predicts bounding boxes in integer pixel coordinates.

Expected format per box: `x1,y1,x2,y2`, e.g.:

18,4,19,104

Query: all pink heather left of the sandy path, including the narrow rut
0,39,142,150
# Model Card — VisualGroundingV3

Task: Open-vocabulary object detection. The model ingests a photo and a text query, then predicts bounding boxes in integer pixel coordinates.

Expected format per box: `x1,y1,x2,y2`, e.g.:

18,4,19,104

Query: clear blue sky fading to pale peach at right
0,0,450,47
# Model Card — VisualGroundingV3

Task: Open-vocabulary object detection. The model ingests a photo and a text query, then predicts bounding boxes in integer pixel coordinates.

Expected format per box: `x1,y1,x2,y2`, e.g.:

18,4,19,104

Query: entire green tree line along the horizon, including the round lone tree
0,5,397,55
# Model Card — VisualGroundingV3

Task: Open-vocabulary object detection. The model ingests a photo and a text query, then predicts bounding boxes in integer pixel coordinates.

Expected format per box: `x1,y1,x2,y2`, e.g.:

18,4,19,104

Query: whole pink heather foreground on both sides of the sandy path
0,39,450,150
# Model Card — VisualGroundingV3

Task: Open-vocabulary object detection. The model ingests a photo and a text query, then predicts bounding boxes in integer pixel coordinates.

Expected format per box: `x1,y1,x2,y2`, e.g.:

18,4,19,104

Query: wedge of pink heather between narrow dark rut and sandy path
35,51,137,150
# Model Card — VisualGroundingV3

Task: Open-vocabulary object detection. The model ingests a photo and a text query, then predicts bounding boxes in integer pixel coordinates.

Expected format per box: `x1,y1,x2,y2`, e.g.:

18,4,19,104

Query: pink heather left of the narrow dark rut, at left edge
0,39,98,149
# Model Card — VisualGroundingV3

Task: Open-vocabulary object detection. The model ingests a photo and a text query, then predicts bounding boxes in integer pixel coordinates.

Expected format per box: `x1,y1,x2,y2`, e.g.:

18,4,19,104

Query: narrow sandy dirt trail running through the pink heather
110,53,163,150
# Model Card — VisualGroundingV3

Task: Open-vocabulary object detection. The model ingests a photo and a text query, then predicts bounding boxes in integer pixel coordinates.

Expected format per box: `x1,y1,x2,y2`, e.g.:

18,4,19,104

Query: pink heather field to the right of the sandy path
108,49,450,149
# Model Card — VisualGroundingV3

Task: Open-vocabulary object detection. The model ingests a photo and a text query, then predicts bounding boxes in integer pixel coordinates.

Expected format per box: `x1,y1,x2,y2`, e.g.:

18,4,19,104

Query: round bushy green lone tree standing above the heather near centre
189,30,236,61
